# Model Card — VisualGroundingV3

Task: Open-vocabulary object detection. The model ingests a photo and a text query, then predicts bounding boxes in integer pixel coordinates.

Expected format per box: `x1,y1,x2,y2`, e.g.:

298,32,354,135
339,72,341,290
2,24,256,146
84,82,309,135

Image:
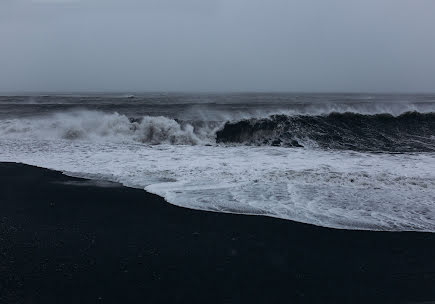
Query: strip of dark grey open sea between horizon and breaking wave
0,94,435,117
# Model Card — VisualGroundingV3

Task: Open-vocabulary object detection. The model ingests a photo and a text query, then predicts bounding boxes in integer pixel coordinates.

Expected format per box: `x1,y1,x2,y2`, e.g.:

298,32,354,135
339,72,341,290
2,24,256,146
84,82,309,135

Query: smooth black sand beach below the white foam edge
0,163,435,303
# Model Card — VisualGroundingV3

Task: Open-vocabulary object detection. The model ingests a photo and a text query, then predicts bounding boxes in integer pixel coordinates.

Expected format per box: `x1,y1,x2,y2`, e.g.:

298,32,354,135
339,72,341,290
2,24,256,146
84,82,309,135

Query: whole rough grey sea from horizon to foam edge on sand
0,93,435,232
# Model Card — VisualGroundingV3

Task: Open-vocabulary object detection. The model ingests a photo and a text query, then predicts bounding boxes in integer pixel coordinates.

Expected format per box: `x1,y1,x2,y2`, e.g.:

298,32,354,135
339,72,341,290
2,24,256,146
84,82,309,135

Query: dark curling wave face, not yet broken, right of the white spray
216,112,435,152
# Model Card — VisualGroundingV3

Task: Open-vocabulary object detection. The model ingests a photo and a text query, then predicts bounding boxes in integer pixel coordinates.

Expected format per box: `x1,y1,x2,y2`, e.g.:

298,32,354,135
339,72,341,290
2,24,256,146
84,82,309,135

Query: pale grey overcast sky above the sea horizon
0,0,435,92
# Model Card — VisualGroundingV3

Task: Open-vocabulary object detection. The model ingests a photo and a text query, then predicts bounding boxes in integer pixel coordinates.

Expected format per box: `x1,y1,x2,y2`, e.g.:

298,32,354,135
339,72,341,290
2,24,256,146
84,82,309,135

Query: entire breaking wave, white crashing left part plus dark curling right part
0,110,435,152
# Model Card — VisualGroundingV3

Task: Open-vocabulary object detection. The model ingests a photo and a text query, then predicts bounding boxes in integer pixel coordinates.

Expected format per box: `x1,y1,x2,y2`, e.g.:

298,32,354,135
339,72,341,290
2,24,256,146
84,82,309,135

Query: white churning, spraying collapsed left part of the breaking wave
0,111,213,145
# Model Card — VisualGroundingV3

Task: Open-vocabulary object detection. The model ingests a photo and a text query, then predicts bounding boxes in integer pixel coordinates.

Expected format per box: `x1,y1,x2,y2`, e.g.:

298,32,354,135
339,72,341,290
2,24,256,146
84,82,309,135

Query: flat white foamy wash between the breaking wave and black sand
0,137,435,232
